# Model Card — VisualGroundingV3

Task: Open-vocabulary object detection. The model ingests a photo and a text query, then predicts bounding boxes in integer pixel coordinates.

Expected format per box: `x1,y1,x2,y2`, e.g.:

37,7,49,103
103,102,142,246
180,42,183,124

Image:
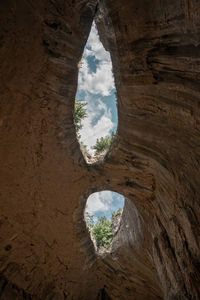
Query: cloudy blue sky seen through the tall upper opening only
76,23,118,154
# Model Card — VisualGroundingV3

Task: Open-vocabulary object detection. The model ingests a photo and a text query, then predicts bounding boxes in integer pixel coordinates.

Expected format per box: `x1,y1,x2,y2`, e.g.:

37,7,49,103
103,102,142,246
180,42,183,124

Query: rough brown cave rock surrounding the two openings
0,0,200,300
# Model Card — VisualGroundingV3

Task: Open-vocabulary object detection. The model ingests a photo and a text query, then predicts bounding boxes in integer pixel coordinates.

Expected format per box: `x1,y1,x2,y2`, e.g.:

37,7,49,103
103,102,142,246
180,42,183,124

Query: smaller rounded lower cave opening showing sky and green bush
84,190,125,254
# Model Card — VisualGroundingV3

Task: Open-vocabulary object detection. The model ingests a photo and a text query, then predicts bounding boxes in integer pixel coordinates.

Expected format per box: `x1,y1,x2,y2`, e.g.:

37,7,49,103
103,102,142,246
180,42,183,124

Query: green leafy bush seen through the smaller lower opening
92,216,112,248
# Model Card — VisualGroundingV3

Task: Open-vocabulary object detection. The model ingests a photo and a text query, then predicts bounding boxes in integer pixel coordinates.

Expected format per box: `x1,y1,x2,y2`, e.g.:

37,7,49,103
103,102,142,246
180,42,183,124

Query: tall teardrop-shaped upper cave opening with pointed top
74,22,118,163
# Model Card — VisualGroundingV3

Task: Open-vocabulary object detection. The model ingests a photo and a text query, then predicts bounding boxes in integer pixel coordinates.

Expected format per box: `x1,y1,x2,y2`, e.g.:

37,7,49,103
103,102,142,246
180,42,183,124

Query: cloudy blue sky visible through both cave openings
76,23,124,222
